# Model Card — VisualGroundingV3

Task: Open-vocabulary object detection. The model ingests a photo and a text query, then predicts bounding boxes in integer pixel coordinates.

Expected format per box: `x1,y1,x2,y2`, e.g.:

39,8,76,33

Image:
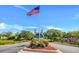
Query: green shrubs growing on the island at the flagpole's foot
29,39,49,48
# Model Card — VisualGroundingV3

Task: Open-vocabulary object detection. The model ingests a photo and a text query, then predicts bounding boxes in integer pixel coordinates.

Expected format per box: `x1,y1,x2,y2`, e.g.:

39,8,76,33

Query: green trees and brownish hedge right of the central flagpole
44,29,79,45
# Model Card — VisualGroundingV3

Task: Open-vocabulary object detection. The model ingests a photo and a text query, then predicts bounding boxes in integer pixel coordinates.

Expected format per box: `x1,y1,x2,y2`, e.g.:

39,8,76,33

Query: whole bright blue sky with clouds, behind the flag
0,5,79,32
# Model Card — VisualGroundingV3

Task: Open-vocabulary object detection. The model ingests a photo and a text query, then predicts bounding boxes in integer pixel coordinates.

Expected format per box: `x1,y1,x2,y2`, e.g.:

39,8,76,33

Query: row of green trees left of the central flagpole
0,30,34,41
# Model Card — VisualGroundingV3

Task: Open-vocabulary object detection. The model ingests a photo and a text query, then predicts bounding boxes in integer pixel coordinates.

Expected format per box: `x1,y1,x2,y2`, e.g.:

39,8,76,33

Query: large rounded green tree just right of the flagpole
44,29,63,41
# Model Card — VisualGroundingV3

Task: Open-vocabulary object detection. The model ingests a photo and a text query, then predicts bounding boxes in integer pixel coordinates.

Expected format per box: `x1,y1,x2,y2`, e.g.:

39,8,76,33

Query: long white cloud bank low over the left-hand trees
0,23,37,31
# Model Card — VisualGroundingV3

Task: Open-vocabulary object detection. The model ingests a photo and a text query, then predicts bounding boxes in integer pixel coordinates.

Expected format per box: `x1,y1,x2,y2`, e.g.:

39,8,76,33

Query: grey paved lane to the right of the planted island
50,43,79,53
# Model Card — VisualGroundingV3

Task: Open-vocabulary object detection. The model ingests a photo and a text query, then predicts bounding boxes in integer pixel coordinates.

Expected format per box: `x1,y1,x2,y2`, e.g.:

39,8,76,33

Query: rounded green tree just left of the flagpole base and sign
15,30,34,40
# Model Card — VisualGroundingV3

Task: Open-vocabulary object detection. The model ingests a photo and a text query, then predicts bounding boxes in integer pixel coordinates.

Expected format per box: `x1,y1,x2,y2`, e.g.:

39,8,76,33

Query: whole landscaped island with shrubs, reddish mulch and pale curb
20,39,60,53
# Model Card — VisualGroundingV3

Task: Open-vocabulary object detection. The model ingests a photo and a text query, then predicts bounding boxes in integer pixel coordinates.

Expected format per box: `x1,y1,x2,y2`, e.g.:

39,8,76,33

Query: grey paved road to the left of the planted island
0,43,29,53
